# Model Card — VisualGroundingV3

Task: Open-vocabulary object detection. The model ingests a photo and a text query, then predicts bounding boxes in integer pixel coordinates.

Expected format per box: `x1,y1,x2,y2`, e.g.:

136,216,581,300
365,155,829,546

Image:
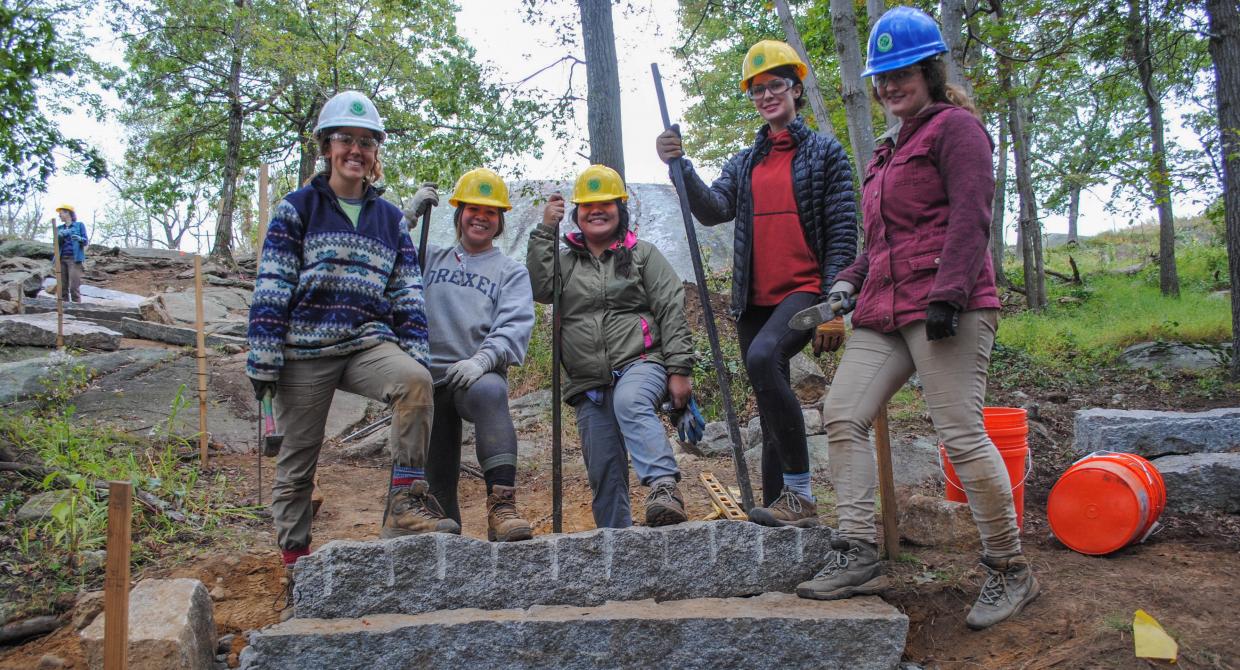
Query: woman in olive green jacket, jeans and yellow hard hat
526,165,693,527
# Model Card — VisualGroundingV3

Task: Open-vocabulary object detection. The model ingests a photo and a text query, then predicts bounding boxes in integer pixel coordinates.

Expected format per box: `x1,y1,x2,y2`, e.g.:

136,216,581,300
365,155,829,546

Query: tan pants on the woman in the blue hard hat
823,309,1021,558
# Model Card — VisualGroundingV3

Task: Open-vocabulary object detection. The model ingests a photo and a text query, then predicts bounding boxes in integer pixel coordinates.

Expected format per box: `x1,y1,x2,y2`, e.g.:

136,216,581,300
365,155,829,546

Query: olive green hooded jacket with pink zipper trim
526,225,693,403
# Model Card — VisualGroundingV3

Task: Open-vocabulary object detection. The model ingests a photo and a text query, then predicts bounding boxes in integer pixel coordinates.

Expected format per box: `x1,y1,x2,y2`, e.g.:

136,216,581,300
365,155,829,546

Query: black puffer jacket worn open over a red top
684,115,857,319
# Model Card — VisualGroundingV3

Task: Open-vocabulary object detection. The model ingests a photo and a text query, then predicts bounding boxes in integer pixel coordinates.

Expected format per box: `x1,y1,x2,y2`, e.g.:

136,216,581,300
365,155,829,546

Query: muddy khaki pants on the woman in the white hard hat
272,342,434,551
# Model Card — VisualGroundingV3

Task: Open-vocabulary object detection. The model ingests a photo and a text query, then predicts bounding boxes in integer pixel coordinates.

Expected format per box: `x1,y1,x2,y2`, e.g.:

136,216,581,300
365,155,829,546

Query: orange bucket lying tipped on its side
1047,452,1167,556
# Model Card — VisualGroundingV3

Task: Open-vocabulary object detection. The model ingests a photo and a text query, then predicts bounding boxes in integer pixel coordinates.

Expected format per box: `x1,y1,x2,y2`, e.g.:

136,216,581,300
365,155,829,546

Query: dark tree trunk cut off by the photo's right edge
1205,0,1240,381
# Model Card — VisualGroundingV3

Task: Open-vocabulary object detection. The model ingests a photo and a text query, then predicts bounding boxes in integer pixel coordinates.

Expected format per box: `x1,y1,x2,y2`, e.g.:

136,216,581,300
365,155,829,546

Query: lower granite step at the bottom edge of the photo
241,593,909,670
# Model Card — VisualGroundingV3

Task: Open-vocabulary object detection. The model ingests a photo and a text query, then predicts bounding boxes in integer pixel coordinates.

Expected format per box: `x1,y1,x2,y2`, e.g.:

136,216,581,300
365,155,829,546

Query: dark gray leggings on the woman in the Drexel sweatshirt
427,372,517,524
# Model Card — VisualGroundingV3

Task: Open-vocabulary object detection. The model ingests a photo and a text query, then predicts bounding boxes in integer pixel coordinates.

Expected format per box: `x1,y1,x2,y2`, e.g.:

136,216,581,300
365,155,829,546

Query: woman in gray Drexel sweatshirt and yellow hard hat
405,168,534,542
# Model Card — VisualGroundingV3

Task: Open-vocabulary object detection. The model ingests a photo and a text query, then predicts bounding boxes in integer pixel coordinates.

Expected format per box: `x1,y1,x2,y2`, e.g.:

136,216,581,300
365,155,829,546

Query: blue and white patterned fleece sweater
246,175,430,381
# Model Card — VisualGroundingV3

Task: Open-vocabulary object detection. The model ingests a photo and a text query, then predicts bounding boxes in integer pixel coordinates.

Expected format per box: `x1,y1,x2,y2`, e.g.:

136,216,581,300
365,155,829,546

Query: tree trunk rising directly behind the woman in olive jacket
577,0,624,179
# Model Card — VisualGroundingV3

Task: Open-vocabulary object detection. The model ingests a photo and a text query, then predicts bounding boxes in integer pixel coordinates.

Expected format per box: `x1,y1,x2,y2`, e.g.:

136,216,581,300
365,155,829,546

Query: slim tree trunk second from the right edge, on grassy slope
1128,0,1179,297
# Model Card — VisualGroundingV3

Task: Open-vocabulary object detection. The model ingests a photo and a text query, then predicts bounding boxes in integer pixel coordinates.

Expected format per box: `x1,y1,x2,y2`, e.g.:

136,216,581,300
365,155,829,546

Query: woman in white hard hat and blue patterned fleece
246,91,460,610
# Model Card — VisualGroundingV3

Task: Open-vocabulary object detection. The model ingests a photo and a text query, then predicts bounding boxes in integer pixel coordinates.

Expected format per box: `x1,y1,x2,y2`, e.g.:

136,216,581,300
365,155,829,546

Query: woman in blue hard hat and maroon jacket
797,7,1038,629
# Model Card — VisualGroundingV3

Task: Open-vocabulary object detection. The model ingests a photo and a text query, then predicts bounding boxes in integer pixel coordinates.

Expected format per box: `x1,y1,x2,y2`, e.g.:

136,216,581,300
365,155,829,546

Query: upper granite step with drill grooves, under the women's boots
294,521,832,619
